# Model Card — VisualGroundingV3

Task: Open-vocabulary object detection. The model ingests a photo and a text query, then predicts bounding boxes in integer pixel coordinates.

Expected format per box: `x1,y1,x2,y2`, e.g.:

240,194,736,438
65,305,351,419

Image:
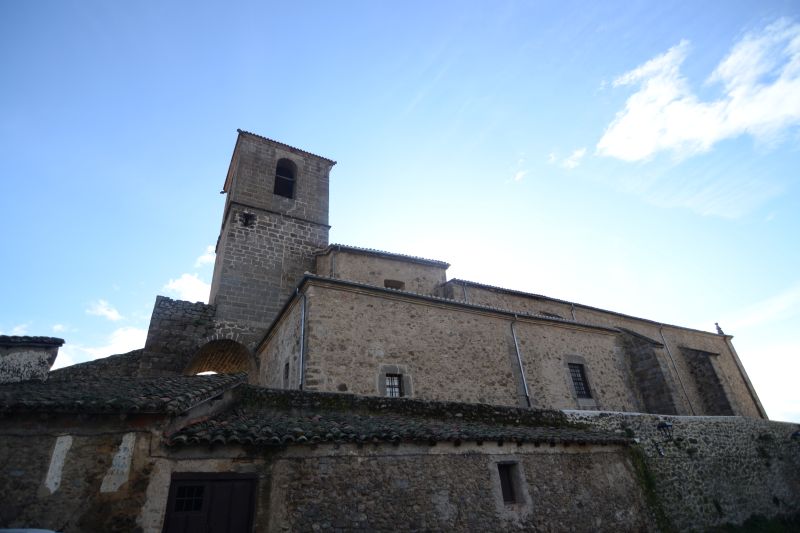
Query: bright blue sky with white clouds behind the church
0,0,800,421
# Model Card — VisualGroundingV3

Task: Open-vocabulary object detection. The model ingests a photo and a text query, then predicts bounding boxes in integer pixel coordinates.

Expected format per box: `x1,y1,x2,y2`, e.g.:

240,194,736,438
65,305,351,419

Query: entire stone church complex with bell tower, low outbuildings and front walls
0,131,800,532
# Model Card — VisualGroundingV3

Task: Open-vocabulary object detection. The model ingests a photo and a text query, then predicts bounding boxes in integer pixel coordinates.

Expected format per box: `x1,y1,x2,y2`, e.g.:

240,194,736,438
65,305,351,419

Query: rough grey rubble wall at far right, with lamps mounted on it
567,411,800,531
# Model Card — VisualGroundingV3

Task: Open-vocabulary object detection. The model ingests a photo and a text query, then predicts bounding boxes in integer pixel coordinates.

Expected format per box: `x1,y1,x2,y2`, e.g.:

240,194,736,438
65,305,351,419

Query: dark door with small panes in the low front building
164,473,256,533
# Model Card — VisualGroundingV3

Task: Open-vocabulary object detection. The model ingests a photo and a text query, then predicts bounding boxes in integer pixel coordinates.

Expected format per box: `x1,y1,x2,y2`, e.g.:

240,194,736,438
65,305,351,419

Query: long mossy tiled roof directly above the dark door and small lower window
167,385,630,447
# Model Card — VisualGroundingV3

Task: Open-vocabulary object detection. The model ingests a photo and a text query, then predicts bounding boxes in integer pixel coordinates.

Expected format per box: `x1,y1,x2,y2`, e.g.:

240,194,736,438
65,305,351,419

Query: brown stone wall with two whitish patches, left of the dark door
0,424,150,533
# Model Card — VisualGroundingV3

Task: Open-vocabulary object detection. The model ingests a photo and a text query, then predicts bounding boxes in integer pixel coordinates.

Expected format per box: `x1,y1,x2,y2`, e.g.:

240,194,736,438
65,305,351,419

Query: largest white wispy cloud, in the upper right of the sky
596,19,800,161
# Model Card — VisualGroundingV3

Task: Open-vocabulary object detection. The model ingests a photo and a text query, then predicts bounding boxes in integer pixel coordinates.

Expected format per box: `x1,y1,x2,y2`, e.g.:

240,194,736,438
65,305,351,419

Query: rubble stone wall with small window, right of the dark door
267,444,653,533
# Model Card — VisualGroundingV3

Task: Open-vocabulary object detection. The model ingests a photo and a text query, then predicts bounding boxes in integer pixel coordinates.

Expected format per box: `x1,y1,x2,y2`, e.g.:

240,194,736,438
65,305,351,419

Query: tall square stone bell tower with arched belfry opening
209,130,336,335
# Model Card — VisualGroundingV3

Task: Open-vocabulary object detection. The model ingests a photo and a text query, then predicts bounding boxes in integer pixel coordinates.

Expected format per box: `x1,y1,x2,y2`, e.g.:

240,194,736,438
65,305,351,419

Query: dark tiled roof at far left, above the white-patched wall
0,374,246,414
